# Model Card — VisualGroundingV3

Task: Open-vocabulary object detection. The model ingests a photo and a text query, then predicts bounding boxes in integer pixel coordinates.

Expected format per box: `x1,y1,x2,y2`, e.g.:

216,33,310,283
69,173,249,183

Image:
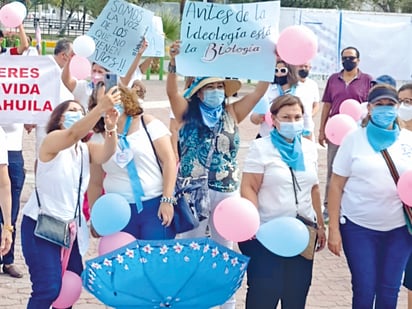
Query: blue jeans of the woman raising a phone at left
21,216,83,309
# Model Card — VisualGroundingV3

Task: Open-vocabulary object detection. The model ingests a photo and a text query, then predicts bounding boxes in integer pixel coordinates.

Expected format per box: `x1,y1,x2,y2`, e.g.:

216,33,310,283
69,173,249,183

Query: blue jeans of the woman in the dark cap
340,219,412,309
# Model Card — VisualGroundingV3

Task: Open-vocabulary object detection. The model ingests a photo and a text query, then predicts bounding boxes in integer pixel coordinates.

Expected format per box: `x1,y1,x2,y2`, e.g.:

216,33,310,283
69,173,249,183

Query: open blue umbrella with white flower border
82,238,249,309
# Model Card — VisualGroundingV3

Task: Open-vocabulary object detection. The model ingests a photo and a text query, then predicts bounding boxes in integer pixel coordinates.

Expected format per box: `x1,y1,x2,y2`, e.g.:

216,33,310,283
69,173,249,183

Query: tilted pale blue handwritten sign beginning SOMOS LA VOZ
87,0,153,76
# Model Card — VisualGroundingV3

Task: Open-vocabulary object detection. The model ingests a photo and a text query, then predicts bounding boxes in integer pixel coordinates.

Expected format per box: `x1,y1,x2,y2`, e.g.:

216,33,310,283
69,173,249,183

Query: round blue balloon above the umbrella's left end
90,193,131,236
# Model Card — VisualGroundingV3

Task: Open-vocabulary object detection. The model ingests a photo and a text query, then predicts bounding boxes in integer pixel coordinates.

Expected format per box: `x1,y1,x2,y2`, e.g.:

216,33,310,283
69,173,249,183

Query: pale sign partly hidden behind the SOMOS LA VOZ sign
143,16,165,57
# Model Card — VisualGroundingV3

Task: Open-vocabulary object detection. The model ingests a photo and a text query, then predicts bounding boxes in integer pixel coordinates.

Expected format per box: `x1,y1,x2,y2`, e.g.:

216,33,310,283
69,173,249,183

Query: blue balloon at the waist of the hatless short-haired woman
256,217,309,257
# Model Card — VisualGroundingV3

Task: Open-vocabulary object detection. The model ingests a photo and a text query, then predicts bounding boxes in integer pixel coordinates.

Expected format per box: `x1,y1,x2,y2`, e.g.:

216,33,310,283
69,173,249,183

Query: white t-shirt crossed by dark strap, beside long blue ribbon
102,119,170,203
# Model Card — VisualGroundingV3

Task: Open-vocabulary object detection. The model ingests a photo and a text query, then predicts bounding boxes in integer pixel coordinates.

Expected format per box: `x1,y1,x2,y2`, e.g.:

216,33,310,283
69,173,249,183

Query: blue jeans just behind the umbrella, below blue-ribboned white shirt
122,196,176,240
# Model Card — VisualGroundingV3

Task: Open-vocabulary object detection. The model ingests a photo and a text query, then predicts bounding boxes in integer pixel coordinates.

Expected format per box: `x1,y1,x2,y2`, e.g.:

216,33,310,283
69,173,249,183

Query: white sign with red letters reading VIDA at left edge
0,56,60,124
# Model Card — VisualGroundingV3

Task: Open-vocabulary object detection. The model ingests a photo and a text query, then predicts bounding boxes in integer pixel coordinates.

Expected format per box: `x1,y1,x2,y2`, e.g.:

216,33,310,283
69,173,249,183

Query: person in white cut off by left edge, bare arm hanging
0,127,14,257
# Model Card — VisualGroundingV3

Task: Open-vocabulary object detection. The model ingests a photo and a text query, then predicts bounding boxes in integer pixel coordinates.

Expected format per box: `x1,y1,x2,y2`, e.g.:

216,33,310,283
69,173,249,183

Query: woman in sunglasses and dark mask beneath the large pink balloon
250,59,298,138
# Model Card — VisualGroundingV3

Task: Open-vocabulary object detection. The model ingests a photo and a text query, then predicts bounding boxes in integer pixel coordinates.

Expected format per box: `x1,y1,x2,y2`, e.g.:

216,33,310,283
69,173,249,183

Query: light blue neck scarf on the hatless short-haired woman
270,129,305,171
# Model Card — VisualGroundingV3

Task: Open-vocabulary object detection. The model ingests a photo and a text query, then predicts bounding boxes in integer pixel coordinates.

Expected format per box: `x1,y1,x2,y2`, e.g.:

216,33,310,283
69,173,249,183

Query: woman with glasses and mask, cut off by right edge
398,84,412,309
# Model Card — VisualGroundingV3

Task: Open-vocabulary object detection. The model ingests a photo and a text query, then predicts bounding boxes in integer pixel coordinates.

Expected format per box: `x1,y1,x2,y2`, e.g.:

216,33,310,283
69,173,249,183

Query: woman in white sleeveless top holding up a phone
21,87,120,309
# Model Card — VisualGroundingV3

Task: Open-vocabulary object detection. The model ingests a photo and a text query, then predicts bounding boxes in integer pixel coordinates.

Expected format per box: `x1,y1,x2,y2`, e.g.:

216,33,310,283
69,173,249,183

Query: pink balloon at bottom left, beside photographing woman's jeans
53,270,82,308
